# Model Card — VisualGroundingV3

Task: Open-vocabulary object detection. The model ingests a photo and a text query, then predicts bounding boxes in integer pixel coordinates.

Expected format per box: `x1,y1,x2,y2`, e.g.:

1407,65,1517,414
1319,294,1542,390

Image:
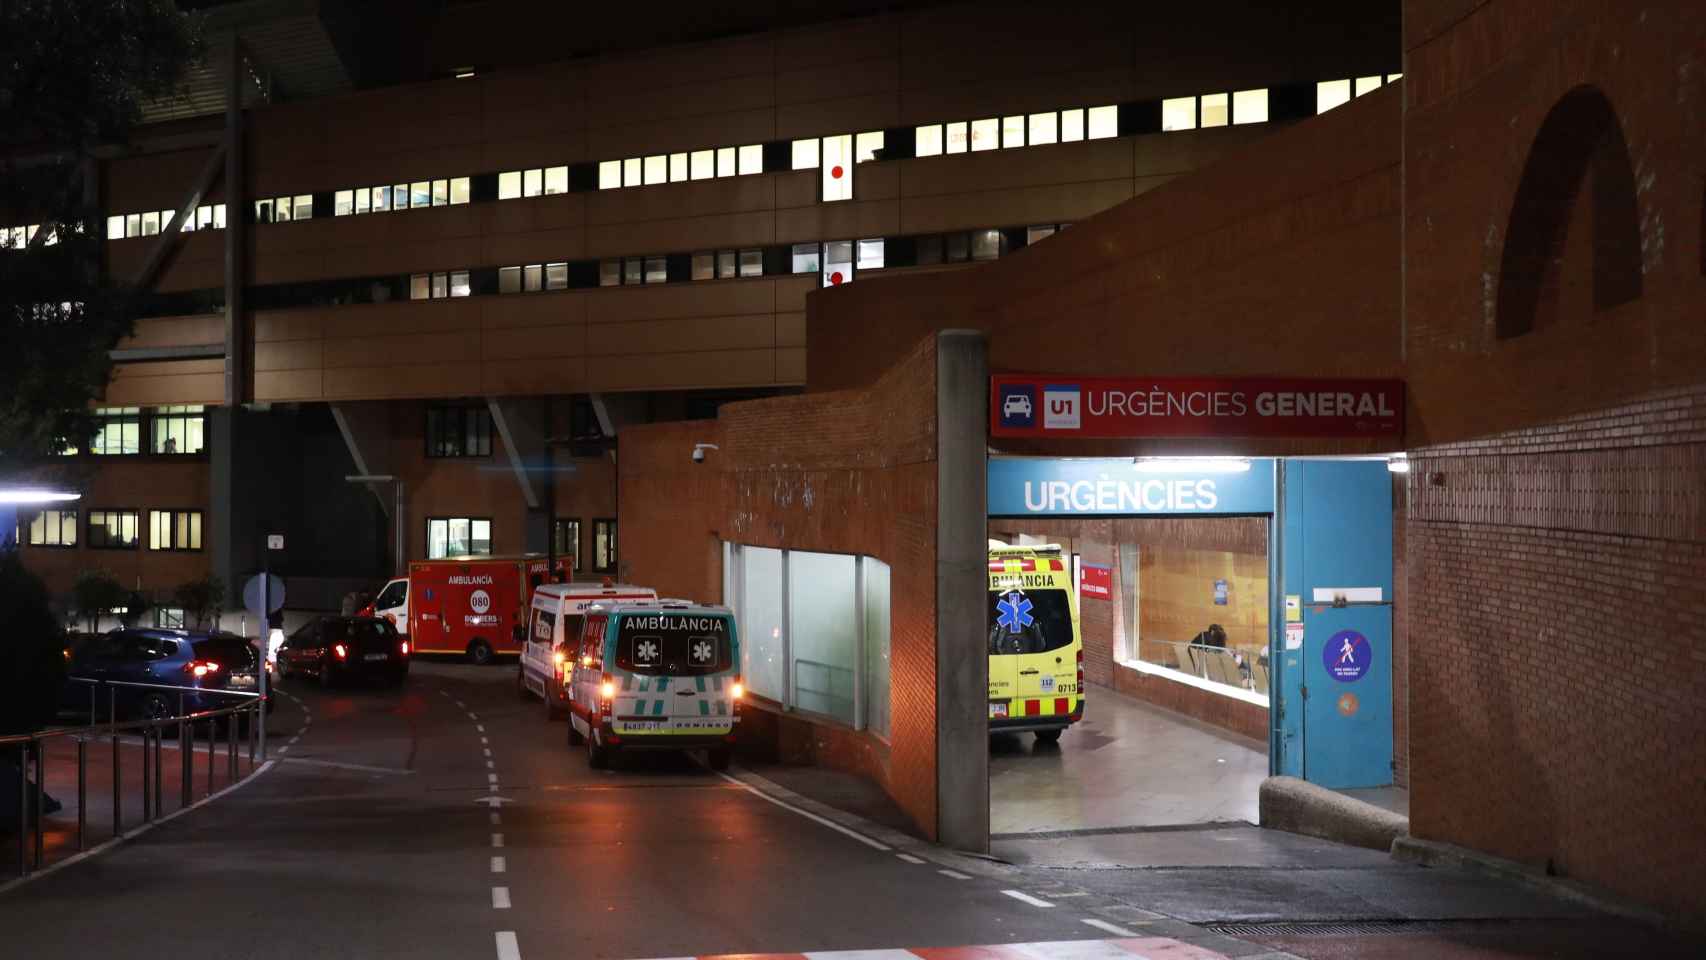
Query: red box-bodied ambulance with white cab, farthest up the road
360,554,570,663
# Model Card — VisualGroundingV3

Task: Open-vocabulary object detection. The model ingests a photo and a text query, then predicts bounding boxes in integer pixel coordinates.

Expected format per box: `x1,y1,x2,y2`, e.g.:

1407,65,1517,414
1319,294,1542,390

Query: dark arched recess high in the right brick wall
1494,85,1641,339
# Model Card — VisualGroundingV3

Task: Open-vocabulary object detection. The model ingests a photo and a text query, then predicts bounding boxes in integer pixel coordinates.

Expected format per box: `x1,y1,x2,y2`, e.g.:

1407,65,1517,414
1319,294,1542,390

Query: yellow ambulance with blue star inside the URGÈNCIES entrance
989,541,1083,743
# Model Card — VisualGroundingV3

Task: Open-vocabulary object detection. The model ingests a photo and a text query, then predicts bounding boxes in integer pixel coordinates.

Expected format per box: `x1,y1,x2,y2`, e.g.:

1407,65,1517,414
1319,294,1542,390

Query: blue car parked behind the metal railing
61,627,273,720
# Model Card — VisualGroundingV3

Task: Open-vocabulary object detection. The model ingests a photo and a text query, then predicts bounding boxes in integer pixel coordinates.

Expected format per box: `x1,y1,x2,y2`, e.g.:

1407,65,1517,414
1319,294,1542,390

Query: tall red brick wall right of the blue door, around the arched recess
1402,0,1706,917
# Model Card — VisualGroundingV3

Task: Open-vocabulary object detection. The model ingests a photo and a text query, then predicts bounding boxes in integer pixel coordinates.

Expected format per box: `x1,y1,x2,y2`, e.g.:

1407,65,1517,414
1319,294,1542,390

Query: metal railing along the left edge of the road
0,677,266,876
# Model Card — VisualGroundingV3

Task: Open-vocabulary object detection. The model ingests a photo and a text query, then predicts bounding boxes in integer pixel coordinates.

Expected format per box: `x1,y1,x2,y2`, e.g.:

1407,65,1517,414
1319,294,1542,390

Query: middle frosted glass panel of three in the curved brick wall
788,551,858,723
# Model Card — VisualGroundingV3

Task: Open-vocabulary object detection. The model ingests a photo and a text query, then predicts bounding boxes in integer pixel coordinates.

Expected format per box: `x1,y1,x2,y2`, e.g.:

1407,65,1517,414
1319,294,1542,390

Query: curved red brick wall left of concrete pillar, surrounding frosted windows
618,338,937,837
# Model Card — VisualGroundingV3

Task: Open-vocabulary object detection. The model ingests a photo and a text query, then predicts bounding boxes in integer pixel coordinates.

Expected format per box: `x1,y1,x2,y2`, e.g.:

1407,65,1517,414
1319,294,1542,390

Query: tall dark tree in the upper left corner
0,0,203,472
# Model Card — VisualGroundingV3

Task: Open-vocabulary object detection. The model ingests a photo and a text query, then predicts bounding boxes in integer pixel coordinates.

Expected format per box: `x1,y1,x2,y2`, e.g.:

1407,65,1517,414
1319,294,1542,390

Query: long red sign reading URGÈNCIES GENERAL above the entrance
989,373,1404,440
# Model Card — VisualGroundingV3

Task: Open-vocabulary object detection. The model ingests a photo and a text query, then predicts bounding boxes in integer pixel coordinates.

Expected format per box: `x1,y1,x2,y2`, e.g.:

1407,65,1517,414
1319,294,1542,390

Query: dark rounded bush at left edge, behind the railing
0,551,65,736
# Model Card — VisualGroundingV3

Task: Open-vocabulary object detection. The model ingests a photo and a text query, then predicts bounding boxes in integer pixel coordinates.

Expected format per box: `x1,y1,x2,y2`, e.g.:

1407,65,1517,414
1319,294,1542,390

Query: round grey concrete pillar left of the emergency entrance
937,331,989,853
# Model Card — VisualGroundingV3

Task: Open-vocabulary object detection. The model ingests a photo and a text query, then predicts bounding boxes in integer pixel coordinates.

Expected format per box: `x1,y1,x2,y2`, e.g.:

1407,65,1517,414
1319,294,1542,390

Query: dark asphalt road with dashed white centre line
0,663,1146,960
